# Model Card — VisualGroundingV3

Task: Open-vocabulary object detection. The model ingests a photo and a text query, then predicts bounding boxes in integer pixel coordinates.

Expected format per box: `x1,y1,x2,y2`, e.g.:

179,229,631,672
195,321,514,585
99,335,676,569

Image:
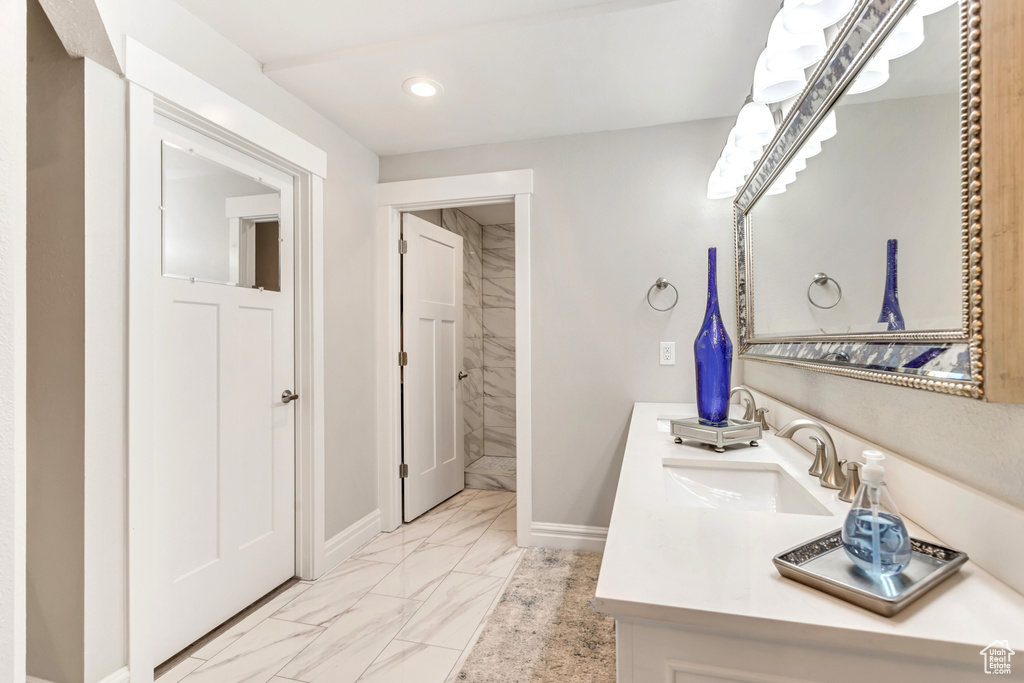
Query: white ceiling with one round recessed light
177,0,778,156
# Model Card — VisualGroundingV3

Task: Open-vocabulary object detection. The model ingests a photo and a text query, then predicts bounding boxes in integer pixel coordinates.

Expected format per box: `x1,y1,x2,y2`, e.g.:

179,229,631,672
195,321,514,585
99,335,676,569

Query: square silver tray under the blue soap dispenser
772,529,968,616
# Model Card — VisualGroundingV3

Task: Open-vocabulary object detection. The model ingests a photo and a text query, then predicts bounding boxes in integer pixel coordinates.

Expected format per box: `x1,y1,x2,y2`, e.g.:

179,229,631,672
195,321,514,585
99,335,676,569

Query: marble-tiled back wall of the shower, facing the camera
482,224,516,464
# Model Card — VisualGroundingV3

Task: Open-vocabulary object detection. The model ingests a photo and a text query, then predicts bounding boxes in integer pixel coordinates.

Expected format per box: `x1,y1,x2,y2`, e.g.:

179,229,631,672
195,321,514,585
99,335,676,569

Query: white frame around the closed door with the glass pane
126,38,327,683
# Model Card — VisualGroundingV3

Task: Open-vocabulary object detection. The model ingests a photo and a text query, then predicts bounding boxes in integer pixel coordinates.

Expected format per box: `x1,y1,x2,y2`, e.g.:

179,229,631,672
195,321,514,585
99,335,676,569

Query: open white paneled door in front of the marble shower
401,214,466,521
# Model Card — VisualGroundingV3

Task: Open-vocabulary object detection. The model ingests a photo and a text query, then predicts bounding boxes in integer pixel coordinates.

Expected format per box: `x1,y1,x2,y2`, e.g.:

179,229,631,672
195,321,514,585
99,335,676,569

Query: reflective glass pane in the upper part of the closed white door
161,140,281,292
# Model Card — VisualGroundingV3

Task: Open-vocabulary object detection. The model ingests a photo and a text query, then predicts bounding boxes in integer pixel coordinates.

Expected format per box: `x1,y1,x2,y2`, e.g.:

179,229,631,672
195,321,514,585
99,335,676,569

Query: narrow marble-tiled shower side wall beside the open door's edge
438,209,484,467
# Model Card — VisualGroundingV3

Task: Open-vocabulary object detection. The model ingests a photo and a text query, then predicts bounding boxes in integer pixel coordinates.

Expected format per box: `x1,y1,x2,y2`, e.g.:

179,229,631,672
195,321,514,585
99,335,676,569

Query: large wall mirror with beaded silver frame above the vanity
736,0,980,396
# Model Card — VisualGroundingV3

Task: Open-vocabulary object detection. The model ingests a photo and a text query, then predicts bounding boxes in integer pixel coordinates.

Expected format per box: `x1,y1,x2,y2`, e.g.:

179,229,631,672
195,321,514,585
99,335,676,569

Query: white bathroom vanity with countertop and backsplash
595,395,1024,683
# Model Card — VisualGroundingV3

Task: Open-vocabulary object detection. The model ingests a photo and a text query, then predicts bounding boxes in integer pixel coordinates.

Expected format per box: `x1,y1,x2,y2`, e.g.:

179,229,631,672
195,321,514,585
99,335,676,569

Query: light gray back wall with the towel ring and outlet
380,119,738,526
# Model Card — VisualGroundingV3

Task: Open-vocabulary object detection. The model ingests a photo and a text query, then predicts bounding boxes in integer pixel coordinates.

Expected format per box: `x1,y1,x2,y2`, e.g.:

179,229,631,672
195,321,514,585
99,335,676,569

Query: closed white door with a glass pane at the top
151,118,295,661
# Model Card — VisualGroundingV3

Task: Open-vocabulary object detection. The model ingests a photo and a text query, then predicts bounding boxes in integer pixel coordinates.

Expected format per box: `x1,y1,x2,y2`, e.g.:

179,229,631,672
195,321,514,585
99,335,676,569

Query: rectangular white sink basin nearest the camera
662,458,831,515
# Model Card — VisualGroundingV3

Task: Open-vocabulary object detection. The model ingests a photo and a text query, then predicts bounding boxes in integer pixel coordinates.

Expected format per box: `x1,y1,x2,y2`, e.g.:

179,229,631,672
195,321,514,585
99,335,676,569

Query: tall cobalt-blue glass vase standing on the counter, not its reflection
693,247,732,425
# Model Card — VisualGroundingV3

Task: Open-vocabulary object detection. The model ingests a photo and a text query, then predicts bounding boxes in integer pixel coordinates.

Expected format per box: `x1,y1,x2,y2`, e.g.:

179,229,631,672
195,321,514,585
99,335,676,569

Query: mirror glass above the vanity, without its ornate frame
751,3,964,338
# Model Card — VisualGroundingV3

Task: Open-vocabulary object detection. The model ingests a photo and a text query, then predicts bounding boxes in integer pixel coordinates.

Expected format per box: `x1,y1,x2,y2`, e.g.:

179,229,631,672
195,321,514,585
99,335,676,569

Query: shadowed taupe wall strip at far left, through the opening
26,2,85,683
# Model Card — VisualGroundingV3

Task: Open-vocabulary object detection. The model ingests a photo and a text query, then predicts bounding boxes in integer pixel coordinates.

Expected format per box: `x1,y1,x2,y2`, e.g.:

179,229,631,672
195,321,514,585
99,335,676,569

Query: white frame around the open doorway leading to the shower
374,169,534,547
